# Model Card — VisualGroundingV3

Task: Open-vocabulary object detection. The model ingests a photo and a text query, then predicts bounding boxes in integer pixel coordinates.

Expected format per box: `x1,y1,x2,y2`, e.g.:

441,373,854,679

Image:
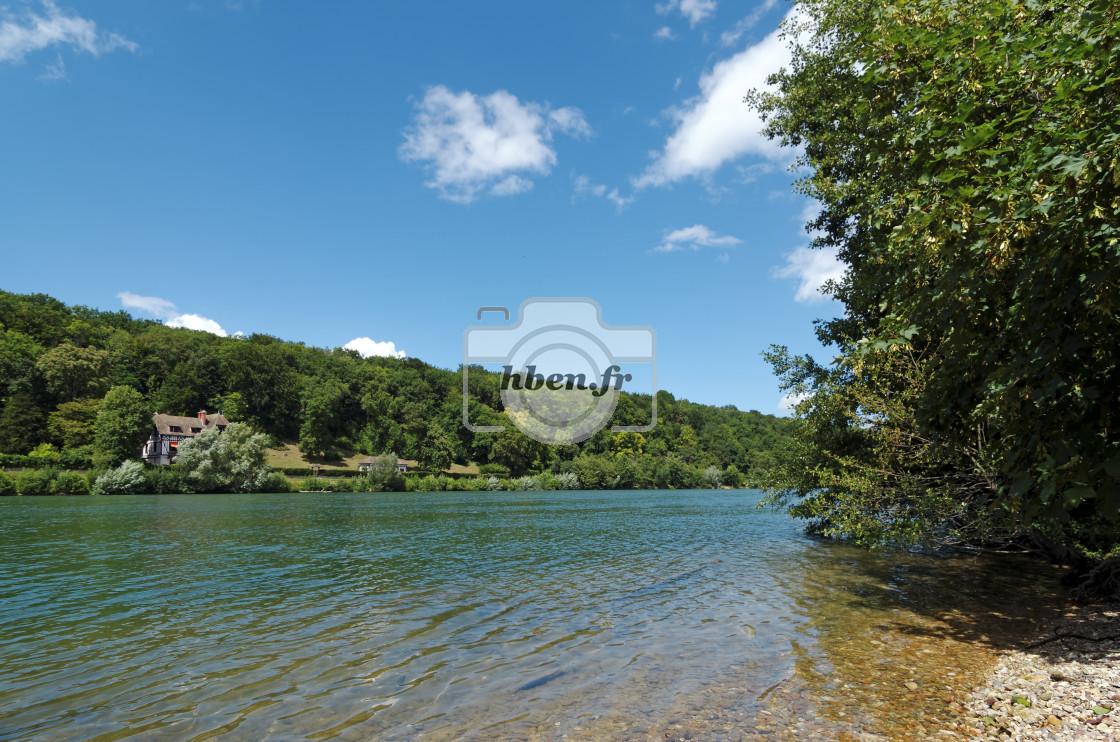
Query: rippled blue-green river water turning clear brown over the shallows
0,491,1055,740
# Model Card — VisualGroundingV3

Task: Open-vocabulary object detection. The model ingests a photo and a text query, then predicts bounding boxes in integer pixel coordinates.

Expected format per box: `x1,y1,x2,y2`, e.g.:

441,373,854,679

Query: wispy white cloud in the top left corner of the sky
0,0,139,63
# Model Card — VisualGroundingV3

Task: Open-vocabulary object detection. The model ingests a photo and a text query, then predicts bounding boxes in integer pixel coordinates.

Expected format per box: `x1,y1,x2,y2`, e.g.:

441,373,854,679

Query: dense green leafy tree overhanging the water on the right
748,0,1120,556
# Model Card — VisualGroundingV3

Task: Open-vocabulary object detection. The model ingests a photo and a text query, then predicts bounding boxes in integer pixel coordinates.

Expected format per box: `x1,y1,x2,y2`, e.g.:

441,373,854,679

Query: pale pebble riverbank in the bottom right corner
946,604,1120,742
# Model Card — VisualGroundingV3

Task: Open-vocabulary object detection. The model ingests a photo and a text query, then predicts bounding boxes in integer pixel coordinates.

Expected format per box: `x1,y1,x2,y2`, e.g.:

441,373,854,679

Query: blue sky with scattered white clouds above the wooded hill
0,0,841,412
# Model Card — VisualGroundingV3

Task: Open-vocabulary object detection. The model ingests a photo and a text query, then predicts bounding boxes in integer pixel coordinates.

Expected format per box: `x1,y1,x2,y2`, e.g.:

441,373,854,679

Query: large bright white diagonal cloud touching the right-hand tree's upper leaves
634,11,793,188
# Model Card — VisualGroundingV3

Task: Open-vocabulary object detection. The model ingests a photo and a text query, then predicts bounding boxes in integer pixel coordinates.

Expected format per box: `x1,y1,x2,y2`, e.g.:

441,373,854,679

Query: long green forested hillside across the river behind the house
0,291,794,488
